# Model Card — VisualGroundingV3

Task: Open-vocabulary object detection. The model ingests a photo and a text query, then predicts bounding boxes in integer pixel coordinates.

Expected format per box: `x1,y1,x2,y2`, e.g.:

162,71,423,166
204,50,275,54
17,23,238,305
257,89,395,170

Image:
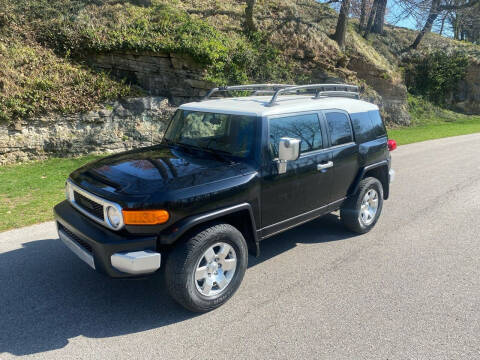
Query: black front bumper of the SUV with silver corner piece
53,201,161,278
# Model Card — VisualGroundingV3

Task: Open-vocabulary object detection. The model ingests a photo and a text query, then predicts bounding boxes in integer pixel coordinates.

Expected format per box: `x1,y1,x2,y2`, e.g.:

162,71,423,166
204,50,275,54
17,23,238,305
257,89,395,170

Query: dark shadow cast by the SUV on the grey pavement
0,215,352,355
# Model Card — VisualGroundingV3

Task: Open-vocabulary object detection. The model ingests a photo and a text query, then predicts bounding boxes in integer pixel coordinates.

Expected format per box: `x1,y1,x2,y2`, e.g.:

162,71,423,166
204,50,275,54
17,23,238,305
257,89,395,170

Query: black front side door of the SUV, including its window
261,112,332,227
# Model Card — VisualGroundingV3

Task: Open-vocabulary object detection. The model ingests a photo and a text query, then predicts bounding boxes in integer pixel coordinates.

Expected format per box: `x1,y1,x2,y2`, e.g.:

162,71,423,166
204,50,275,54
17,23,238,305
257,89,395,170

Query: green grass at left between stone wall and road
0,156,99,231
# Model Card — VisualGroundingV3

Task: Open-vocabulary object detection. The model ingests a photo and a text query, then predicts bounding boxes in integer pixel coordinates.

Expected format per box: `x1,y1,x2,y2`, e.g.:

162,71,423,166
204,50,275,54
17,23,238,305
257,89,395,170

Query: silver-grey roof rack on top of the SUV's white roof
203,84,360,106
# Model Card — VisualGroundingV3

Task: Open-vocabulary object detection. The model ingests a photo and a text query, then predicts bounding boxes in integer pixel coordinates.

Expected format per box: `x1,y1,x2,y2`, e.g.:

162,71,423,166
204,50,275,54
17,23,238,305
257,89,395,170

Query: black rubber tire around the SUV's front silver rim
165,224,248,312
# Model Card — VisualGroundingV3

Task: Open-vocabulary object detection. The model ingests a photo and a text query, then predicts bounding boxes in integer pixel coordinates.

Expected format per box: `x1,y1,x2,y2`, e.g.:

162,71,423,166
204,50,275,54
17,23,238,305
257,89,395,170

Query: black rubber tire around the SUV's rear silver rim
340,177,383,234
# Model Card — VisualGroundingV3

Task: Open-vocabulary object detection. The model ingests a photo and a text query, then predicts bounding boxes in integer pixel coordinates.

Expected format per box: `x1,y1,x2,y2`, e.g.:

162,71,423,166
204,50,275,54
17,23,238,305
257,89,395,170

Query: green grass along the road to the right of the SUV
388,95,480,145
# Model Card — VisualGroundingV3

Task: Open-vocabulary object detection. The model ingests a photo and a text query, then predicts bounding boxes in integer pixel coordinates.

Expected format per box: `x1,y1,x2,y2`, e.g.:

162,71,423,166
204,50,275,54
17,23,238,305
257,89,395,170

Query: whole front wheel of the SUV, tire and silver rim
165,224,248,312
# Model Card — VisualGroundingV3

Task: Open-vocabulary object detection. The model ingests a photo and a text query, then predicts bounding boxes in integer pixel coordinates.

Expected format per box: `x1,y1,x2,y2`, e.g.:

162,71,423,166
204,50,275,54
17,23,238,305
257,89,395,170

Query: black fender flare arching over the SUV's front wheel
159,203,260,256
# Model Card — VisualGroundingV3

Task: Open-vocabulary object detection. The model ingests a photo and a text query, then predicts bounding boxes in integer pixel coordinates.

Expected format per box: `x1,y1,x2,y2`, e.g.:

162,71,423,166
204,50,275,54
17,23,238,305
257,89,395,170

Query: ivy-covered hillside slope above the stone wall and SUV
0,0,480,125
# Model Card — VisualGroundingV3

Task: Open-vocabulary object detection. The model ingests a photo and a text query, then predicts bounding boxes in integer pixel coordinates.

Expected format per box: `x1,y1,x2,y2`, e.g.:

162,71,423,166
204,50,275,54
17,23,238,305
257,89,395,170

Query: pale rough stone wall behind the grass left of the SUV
0,97,175,165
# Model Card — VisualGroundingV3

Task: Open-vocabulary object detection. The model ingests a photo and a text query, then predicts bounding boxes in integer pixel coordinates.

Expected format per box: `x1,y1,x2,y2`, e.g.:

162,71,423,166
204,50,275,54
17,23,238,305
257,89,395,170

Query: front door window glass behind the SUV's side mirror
269,114,323,157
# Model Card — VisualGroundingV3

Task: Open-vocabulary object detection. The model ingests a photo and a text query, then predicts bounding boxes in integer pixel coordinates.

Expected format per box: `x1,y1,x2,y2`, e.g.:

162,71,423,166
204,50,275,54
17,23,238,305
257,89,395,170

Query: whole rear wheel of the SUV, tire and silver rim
340,177,383,234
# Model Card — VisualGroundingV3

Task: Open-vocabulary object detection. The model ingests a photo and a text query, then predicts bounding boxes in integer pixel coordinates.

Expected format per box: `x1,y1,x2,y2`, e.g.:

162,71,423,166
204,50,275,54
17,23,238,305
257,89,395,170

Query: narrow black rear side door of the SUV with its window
324,110,359,202
